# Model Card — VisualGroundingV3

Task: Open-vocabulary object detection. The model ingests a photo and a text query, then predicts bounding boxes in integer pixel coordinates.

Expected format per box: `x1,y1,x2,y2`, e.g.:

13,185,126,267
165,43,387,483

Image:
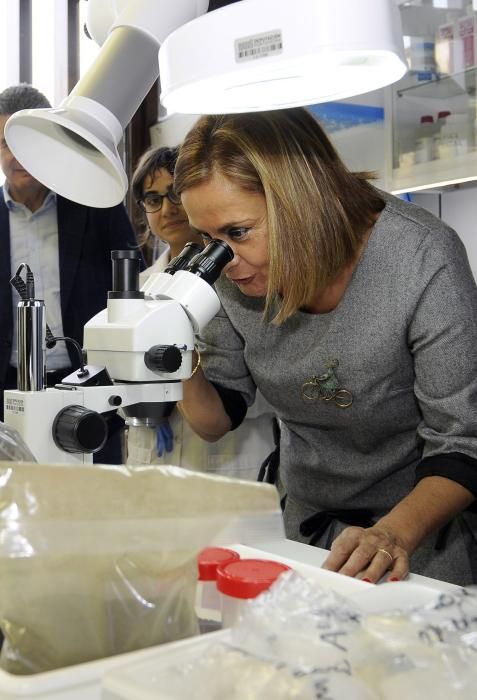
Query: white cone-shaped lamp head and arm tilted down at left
5,0,208,207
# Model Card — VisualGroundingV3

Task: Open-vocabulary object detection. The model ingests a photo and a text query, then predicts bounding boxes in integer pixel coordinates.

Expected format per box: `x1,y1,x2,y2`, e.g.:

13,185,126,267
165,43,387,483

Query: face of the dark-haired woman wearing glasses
143,168,202,252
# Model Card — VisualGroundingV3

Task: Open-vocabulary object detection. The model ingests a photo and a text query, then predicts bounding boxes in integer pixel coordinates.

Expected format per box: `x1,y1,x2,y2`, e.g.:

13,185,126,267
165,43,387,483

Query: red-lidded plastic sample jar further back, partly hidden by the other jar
196,547,240,631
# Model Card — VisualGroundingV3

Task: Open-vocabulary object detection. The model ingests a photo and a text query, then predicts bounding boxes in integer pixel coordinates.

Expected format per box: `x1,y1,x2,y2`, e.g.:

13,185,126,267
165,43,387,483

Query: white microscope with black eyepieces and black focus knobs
4,241,233,464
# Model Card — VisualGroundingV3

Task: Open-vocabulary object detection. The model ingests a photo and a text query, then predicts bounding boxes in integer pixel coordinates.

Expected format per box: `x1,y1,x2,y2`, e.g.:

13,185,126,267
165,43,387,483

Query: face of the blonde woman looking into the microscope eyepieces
182,173,269,297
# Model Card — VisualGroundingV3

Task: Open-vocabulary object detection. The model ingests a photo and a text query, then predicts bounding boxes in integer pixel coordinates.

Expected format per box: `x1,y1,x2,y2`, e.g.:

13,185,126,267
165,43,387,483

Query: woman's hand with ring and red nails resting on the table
323,524,409,583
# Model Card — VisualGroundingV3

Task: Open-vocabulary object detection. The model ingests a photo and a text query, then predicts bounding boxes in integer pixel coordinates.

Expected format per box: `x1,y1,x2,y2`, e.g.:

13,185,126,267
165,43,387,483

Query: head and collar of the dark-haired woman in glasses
131,147,203,285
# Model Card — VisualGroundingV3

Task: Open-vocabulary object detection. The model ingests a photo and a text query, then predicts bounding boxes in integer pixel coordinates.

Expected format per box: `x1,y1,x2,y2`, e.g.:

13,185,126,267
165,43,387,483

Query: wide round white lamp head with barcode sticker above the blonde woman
159,0,407,114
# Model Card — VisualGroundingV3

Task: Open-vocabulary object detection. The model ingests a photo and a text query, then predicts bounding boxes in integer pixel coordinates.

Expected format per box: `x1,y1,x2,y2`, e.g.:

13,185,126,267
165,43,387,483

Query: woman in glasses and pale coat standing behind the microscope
127,147,274,480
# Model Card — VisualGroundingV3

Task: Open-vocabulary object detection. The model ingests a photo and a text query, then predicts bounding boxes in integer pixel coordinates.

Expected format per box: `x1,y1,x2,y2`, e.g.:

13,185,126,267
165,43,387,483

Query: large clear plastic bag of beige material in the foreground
0,462,280,674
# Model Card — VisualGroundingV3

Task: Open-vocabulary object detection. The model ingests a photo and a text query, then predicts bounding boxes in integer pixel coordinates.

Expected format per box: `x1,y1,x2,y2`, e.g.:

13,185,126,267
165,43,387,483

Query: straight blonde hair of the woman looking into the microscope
174,108,384,324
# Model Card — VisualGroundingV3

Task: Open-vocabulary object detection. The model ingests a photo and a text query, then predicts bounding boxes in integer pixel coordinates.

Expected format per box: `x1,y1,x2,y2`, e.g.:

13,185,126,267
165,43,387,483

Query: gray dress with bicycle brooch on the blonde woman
196,195,477,585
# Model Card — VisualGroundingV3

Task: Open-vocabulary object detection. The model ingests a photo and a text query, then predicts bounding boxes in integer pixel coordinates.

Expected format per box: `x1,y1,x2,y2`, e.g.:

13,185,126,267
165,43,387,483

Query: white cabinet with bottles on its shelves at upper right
386,0,477,193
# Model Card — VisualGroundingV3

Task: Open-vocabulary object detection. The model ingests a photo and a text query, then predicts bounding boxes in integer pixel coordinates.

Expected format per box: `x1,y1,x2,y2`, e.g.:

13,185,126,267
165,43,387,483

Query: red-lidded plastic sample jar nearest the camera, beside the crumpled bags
217,559,290,627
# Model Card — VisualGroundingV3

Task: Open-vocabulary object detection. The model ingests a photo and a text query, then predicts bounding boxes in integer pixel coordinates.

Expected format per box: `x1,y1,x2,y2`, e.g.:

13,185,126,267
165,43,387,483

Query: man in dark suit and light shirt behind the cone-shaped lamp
0,84,141,464
